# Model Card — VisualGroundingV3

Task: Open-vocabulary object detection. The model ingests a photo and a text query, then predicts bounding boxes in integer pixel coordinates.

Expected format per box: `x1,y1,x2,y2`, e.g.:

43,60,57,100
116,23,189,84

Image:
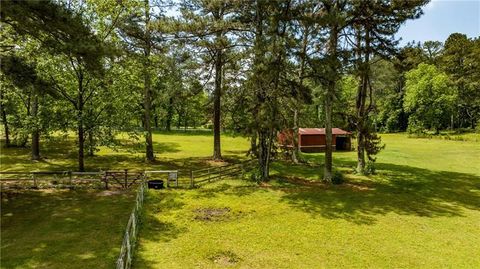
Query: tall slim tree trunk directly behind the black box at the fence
143,0,155,162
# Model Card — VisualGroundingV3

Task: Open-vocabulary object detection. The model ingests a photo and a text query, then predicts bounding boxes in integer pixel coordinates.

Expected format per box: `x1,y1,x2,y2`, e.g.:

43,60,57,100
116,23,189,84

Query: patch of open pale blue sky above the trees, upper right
395,0,480,45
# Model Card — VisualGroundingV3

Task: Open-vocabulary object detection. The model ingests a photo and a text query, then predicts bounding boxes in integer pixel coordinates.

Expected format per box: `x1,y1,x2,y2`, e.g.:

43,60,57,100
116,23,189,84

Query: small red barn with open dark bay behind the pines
278,128,352,152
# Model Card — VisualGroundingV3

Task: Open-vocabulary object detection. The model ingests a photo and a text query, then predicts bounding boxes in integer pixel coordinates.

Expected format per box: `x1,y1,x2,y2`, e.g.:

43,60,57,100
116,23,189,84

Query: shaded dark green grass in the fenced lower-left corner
0,190,134,269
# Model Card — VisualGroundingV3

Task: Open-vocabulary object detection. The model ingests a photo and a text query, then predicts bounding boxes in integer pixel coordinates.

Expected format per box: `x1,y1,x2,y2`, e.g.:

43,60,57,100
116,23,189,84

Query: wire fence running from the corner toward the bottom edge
116,178,146,269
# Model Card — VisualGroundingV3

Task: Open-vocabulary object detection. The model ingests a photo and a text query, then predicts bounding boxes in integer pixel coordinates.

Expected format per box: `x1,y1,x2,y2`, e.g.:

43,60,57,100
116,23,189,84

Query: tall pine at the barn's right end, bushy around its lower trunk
349,0,428,174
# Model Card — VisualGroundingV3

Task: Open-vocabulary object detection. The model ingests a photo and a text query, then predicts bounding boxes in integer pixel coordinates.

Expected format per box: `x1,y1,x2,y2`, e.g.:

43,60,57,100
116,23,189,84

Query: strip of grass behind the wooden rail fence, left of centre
0,130,250,171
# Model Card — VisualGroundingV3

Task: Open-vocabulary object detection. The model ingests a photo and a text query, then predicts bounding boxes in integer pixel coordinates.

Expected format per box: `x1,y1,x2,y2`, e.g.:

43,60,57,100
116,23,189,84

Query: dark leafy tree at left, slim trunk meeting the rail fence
2,1,110,171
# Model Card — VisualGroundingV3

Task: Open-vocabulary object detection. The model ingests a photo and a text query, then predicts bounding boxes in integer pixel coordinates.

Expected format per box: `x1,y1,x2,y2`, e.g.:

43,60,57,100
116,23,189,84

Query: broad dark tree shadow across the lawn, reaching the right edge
282,163,480,224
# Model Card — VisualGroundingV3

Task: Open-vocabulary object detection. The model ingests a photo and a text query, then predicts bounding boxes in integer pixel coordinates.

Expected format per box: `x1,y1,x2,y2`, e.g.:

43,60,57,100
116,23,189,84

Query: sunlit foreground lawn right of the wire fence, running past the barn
135,134,480,268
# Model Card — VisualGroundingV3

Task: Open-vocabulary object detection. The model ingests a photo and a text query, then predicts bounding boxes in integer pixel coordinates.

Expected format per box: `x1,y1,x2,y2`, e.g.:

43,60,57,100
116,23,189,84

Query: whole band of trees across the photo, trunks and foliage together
1,0,480,181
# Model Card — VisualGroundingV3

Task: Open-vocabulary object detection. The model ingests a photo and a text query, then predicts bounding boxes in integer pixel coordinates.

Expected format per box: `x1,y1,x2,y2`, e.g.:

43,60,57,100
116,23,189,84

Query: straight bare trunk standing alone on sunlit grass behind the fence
213,45,223,160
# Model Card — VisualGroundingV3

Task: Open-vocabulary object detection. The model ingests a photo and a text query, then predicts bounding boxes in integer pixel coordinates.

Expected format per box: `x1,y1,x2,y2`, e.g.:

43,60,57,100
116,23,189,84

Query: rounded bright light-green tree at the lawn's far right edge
404,64,457,133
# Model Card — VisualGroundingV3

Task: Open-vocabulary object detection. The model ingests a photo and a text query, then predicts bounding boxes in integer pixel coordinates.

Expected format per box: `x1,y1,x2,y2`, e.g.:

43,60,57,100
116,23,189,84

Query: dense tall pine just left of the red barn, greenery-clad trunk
245,0,309,181
